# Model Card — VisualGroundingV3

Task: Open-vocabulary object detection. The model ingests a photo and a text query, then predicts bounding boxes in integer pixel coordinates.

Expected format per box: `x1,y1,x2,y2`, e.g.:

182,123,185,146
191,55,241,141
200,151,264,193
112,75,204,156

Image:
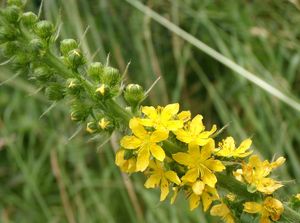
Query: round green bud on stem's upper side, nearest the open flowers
124,84,145,107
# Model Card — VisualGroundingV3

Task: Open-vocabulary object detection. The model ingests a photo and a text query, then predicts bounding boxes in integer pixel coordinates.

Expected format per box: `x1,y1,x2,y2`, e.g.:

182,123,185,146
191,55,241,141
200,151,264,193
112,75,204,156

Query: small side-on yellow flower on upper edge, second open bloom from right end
216,137,253,158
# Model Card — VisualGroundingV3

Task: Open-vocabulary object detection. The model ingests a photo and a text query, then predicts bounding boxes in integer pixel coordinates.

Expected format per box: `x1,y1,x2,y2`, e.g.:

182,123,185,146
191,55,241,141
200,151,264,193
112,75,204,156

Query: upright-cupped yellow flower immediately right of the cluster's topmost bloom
174,115,217,146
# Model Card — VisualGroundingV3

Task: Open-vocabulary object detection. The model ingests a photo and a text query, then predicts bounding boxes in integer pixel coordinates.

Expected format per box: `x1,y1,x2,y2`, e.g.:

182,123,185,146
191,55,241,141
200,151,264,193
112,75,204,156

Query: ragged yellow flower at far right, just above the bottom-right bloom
234,155,285,194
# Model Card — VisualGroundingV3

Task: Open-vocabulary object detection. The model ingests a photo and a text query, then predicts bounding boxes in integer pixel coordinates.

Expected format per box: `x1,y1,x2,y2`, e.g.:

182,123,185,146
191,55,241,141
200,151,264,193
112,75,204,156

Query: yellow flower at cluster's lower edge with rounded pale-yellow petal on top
188,180,219,211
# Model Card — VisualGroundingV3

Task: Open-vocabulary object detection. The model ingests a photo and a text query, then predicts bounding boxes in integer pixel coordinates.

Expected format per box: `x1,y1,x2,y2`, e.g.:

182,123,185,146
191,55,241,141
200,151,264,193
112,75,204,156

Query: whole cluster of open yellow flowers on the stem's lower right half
116,103,285,223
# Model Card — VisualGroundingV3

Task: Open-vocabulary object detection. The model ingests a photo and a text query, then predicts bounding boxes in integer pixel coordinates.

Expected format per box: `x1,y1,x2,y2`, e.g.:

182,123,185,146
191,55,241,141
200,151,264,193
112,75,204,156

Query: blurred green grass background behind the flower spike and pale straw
0,0,300,223
